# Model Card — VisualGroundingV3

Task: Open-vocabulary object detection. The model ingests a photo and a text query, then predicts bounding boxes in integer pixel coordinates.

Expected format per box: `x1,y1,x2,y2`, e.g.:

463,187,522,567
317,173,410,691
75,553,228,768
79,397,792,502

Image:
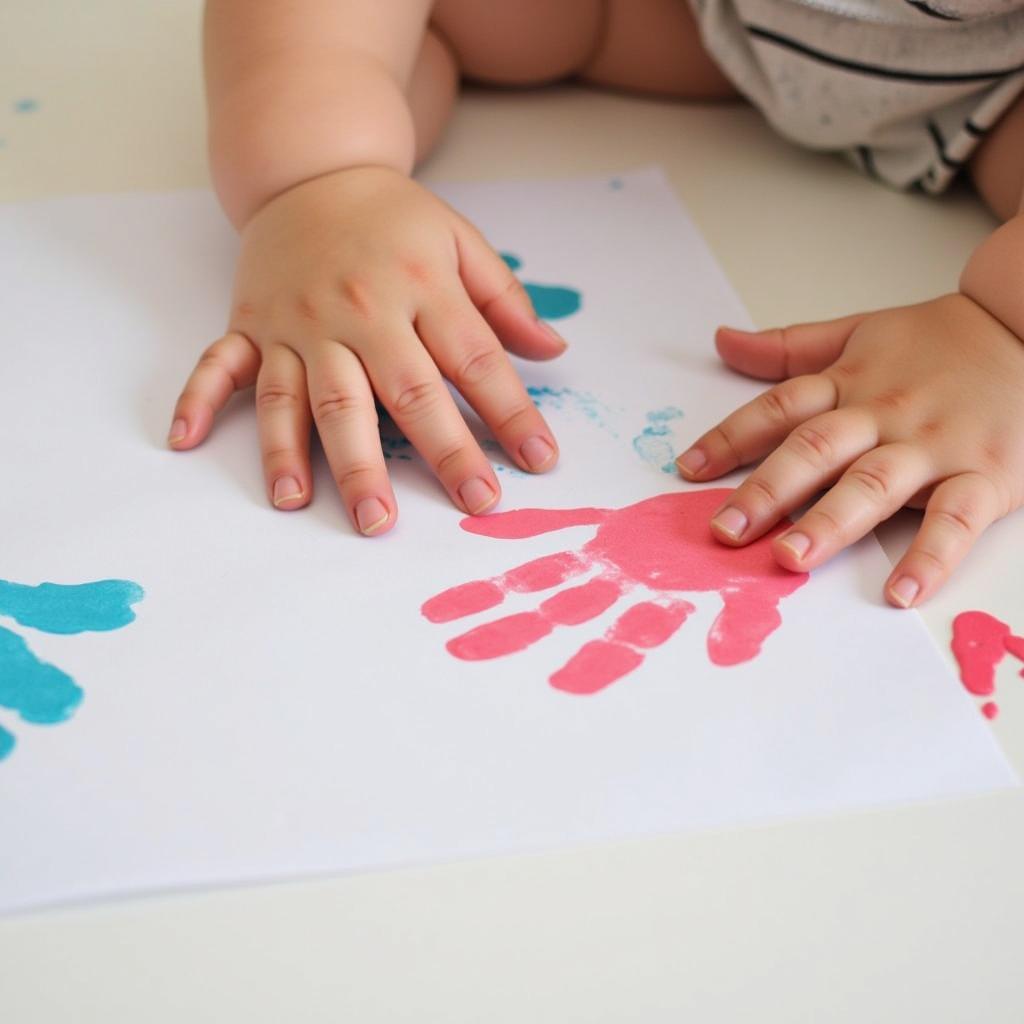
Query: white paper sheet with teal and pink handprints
0,172,1015,909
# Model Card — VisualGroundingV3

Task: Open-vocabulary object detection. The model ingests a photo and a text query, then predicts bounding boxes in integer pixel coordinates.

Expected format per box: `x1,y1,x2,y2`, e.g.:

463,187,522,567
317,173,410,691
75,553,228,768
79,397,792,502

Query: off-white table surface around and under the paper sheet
0,0,1024,1024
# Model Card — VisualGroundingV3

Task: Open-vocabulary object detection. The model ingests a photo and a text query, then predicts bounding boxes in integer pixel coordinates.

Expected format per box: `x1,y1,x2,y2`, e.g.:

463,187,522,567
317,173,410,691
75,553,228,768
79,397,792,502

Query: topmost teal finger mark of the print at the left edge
0,580,144,634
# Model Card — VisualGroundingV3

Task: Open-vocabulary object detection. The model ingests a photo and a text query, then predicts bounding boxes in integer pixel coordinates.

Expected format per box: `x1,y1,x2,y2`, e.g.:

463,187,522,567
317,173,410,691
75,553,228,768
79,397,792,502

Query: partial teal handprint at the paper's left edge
0,580,144,761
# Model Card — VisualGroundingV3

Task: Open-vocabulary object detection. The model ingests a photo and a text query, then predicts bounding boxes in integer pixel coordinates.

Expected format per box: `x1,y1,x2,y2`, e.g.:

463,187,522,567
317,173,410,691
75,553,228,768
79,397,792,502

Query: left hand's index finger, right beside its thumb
416,296,558,473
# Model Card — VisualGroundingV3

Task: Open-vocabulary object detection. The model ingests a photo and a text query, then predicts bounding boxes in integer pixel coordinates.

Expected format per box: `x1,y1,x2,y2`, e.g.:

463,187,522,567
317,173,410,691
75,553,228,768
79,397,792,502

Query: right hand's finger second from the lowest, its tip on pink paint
772,444,935,571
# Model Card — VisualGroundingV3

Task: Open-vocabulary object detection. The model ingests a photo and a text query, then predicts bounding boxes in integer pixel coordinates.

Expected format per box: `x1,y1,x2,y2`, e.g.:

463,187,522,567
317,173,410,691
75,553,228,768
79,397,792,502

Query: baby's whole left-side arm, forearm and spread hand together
169,0,564,534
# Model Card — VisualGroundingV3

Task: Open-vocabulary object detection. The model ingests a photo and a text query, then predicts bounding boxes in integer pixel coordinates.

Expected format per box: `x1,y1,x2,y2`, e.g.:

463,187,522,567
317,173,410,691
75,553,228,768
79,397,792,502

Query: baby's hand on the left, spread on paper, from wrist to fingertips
169,167,565,534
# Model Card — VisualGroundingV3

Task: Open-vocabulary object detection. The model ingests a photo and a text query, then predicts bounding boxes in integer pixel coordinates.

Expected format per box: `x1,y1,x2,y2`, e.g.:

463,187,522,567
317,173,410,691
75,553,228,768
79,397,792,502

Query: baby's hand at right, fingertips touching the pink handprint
678,294,1024,607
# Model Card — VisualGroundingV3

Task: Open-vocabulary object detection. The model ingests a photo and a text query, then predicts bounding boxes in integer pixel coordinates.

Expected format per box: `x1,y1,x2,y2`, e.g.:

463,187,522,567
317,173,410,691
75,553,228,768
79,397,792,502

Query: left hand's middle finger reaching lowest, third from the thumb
306,342,397,537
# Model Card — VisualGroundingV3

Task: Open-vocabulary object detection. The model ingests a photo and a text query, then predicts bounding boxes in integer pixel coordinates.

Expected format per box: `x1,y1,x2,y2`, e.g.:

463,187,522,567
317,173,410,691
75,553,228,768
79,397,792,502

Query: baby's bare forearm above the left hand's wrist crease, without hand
205,0,431,225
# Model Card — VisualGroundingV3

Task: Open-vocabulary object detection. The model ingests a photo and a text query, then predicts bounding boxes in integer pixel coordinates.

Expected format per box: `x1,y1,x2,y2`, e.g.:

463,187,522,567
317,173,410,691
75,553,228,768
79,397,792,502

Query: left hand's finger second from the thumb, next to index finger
364,323,501,515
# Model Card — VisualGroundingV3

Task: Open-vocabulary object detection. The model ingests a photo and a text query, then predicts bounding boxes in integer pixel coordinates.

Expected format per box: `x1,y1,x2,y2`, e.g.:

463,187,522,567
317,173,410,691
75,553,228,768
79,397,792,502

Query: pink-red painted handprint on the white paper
422,487,808,693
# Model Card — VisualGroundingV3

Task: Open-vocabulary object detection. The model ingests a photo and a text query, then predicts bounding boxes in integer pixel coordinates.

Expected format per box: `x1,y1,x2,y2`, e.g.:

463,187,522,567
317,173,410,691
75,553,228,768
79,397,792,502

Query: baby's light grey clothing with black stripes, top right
690,0,1024,193
